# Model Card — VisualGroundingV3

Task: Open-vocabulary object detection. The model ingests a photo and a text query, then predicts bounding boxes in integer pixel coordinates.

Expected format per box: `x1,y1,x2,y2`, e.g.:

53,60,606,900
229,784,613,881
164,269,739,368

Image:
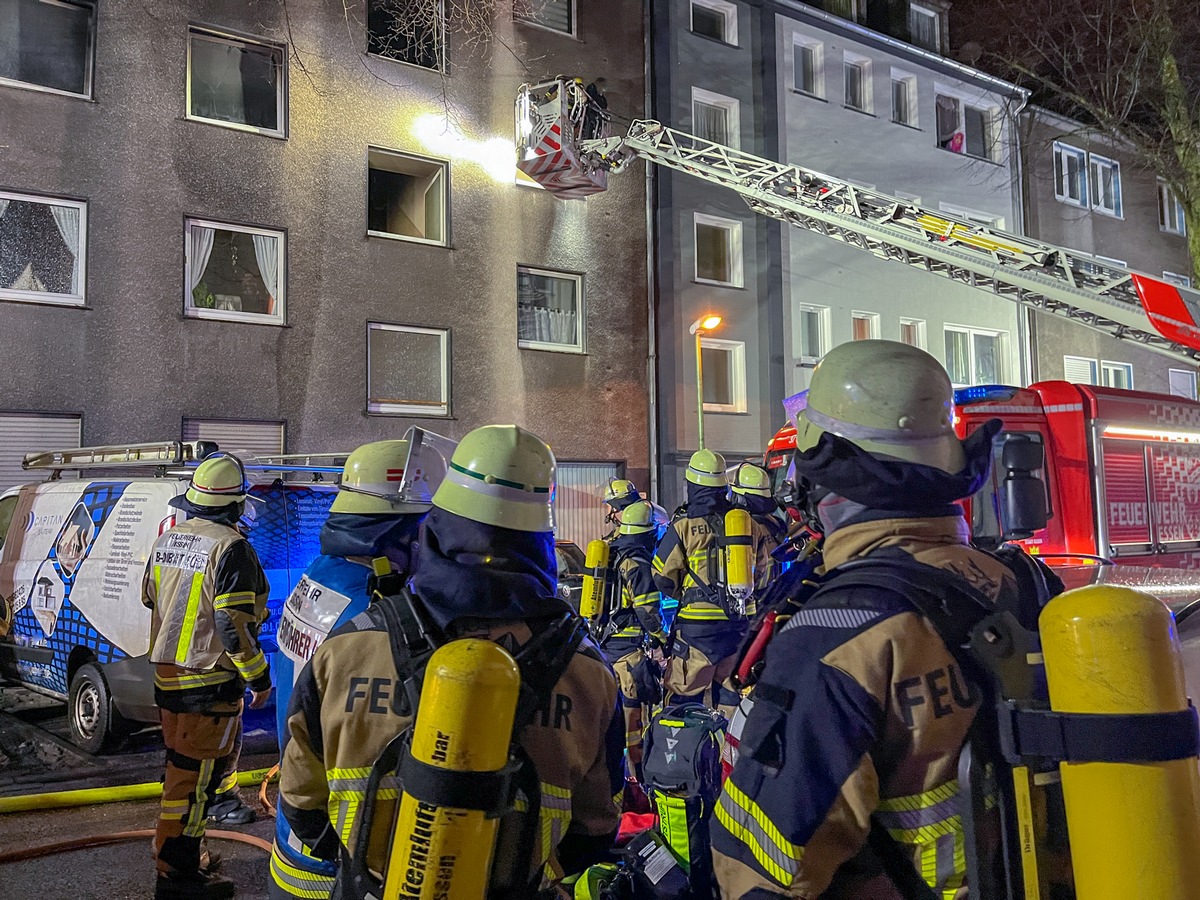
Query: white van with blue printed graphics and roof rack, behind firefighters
0,442,344,752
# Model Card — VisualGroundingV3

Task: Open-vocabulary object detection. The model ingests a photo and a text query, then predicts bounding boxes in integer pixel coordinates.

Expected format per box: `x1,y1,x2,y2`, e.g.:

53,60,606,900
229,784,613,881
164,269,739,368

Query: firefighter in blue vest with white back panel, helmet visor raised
268,440,430,900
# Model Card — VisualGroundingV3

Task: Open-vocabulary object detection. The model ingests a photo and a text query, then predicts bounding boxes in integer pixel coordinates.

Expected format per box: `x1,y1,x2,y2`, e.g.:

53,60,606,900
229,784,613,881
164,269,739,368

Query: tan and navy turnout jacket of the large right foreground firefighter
713,516,1016,900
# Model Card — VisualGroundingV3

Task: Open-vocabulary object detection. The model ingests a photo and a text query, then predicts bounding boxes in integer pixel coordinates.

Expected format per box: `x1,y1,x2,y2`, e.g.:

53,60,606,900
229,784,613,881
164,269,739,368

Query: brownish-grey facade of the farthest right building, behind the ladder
1021,108,1196,400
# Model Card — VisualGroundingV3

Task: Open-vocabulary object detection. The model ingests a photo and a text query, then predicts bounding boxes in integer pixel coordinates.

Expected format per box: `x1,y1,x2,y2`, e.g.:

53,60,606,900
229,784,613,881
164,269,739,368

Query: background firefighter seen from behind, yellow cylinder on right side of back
654,450,746,716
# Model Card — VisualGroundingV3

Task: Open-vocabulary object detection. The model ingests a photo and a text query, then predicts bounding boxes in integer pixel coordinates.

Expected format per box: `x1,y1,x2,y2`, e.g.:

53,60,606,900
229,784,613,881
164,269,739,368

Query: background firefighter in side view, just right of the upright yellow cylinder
600,500,667,781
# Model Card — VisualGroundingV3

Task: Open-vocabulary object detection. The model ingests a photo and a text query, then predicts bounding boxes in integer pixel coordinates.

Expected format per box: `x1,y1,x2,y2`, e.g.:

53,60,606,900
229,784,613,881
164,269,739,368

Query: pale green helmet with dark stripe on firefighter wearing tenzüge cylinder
433,425,554,533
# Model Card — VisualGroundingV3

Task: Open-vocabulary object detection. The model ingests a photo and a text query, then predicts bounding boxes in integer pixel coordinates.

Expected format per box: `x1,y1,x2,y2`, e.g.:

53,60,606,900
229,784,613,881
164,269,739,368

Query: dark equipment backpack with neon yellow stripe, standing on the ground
642,703,728,898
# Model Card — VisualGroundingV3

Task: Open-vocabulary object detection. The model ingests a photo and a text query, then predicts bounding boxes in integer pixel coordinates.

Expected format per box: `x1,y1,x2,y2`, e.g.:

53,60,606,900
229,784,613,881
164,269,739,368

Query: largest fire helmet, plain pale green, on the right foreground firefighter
796,341,966,474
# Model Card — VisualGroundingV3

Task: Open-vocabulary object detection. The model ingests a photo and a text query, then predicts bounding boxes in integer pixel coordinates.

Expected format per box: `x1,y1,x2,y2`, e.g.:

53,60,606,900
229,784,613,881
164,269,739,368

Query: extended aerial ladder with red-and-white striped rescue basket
516,77,1200,366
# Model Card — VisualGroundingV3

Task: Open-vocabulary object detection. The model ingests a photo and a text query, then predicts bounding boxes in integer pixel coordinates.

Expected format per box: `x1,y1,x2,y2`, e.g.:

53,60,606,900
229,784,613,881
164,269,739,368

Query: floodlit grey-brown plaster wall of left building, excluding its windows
0,0,649,487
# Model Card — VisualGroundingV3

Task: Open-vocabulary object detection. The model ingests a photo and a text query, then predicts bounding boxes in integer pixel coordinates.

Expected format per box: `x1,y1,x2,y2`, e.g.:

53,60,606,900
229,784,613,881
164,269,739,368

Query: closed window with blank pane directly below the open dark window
367,322,450,416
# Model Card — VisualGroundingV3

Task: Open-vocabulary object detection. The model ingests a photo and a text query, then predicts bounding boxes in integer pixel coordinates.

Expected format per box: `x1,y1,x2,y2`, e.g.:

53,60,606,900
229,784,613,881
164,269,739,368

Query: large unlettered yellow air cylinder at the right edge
1038,586,1200,900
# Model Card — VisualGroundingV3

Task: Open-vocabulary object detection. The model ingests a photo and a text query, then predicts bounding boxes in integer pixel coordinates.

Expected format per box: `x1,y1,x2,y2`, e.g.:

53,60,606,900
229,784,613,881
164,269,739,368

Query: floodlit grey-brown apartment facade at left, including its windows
0,0,649,540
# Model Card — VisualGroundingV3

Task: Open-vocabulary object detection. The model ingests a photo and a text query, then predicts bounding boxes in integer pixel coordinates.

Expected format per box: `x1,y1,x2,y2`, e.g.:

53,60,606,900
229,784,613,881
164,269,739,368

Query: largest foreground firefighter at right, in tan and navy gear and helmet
713,341,1051,900
